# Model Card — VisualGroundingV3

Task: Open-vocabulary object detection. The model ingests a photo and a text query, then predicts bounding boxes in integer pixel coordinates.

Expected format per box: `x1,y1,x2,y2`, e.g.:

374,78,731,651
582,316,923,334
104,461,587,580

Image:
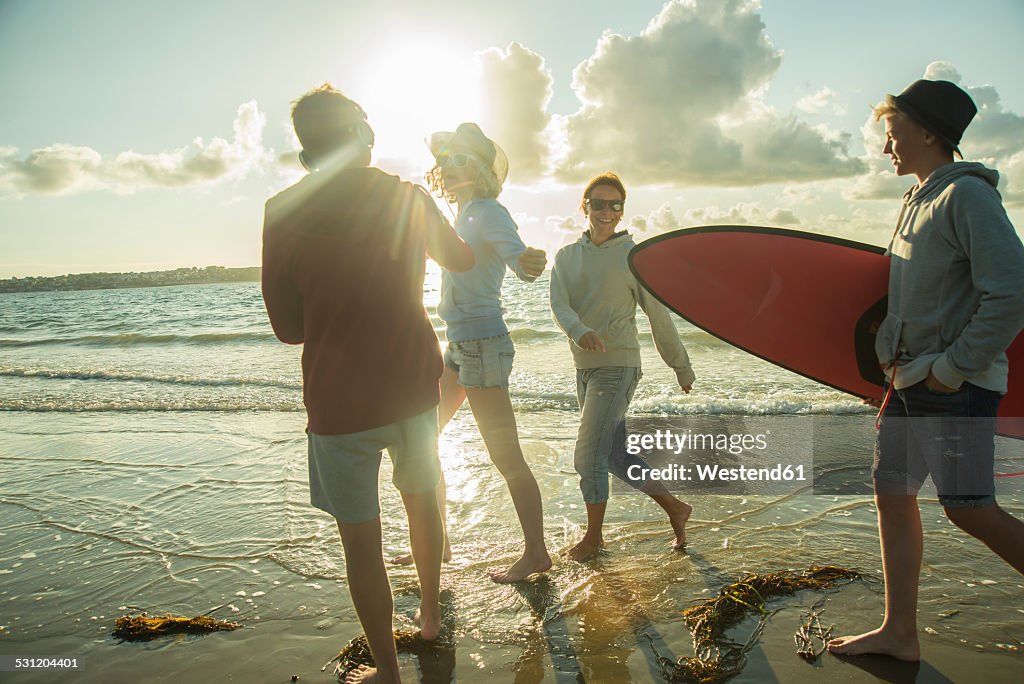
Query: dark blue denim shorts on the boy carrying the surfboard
871,382,1002,508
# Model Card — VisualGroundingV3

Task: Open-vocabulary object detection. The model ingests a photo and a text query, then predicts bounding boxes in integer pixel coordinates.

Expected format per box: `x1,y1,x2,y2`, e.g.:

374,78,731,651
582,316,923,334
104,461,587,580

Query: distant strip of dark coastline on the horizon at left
0,266,260,294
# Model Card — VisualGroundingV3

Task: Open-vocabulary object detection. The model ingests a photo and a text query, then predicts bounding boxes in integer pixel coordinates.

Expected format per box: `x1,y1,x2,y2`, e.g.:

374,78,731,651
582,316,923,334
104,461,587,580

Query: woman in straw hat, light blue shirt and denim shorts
395,123,551,583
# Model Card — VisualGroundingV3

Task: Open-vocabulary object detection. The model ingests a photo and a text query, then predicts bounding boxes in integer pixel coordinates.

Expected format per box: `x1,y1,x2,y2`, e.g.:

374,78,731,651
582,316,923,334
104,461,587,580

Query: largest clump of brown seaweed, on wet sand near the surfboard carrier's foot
651,565,860,682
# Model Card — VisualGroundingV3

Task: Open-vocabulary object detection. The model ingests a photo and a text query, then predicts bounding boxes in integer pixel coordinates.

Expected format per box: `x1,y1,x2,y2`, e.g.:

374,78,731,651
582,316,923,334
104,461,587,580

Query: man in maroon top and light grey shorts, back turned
262,84,473,682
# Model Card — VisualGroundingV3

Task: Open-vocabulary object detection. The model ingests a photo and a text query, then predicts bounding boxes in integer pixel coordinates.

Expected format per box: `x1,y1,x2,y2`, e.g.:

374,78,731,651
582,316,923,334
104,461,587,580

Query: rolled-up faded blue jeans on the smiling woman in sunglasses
572,367,647,504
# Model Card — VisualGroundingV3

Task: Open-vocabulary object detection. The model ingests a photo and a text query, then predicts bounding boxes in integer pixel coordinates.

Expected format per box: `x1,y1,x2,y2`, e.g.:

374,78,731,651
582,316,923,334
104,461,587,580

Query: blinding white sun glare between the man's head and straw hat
352,37,478,161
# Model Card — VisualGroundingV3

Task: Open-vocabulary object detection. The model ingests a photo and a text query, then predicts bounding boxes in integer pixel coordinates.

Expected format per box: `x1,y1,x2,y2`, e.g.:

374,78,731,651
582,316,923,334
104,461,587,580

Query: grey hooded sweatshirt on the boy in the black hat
876,162,1024,392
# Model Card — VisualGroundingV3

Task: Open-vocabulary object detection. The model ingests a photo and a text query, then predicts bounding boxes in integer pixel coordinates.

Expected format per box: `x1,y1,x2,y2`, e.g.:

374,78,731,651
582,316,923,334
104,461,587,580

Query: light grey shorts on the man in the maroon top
306,407,441,524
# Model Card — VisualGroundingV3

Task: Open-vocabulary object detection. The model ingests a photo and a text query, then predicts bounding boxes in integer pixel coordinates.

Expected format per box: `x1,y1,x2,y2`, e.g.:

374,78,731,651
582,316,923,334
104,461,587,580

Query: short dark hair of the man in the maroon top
292,83,367,157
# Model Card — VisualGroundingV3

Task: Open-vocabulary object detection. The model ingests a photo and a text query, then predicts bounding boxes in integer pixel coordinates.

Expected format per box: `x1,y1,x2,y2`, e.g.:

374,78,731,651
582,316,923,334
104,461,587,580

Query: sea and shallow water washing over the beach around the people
0,284,1024,682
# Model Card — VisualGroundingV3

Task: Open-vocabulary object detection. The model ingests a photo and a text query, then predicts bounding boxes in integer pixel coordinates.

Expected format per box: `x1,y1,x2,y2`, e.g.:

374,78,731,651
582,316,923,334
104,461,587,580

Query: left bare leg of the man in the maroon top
338,516,400,682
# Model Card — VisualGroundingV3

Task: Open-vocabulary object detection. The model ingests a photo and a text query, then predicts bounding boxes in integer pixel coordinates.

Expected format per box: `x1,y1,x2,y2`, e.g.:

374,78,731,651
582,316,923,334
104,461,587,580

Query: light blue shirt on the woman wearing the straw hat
437,199,537,342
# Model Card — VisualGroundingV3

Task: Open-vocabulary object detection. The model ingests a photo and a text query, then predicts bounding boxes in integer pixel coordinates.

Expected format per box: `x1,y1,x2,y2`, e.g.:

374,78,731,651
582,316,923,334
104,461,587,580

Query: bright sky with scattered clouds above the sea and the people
0,0,1024,279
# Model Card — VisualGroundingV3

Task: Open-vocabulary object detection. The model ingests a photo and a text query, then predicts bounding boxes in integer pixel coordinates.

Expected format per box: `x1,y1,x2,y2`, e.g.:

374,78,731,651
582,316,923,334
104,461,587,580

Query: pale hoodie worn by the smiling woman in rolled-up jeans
551,232,695,387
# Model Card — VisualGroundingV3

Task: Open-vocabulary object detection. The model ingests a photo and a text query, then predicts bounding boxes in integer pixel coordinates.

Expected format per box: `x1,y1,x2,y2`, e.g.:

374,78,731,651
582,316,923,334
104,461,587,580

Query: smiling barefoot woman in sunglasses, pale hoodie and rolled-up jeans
551,172,694,560
